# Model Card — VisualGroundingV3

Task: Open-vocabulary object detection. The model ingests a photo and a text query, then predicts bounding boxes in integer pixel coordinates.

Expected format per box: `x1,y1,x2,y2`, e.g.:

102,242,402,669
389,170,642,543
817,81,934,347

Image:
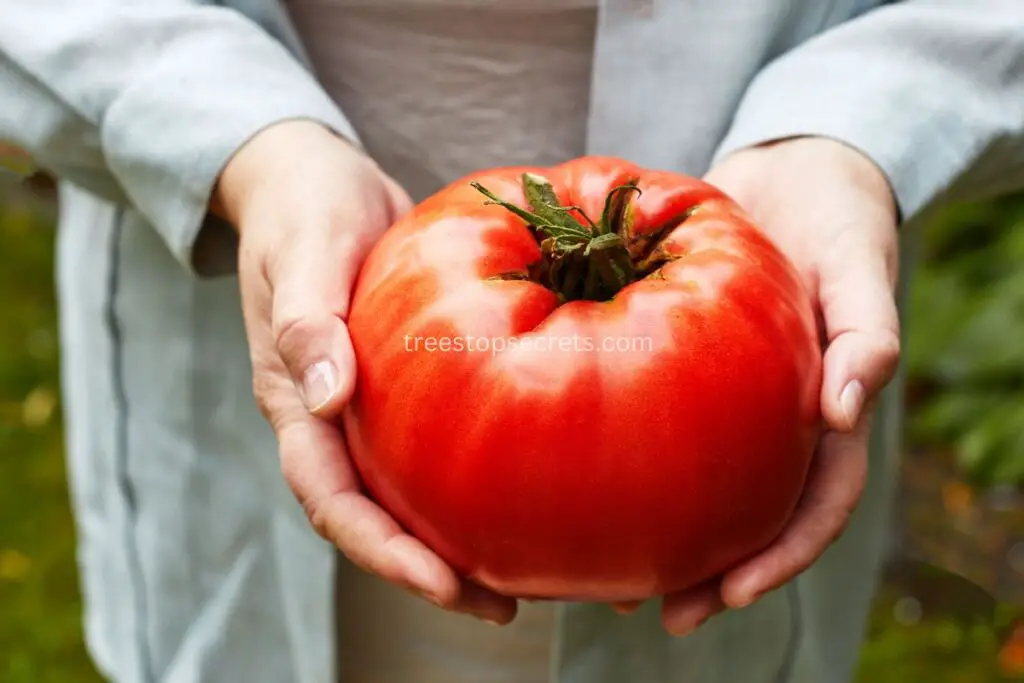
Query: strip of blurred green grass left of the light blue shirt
0,187,98,683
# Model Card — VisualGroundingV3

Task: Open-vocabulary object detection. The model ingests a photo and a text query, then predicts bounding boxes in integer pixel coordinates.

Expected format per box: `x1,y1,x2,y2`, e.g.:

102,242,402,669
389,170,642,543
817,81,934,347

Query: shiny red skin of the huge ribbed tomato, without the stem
342,157,821,601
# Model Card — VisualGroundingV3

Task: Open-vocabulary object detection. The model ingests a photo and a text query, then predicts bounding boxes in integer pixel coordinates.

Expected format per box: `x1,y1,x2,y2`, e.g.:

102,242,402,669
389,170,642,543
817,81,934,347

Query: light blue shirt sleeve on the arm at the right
715,0,1024,220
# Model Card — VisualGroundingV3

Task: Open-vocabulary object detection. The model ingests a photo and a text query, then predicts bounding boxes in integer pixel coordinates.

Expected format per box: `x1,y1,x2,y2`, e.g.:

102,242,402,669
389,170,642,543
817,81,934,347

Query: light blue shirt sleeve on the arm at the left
0,0,358,274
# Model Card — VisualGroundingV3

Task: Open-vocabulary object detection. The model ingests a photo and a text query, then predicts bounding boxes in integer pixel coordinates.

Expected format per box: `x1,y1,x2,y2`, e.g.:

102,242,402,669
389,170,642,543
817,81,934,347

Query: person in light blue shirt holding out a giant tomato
0,0,1024,683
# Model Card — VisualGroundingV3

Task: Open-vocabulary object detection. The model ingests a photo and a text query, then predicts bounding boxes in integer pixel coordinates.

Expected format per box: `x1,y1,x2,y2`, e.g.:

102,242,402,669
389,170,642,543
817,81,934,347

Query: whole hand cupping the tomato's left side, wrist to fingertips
213,122,516,624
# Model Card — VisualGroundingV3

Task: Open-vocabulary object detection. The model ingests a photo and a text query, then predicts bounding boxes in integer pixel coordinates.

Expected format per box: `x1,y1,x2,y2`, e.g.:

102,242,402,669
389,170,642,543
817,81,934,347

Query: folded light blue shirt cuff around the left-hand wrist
101,22,359,276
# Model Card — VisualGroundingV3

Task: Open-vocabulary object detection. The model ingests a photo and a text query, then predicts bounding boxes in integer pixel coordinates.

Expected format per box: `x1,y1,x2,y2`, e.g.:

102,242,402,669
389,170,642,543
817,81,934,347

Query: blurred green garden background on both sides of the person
0,175,1024,683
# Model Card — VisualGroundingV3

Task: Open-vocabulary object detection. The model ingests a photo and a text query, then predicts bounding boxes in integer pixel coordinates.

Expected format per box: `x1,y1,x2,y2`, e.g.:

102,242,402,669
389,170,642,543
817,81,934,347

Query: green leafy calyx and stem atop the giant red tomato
471,173,641,301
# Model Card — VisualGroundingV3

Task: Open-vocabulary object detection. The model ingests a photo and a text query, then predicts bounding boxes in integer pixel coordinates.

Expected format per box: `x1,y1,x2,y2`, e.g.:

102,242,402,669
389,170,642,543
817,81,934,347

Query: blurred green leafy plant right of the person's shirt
905,197,1024,485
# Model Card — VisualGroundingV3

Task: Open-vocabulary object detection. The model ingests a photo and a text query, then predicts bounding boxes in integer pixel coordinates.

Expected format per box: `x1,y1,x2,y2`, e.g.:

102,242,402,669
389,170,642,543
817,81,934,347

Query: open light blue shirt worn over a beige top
0,0,1024,683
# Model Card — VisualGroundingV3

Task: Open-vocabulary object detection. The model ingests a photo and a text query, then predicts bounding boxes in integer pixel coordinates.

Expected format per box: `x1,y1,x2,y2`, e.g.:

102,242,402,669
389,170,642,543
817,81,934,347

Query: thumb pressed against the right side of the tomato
819,244,900,432
